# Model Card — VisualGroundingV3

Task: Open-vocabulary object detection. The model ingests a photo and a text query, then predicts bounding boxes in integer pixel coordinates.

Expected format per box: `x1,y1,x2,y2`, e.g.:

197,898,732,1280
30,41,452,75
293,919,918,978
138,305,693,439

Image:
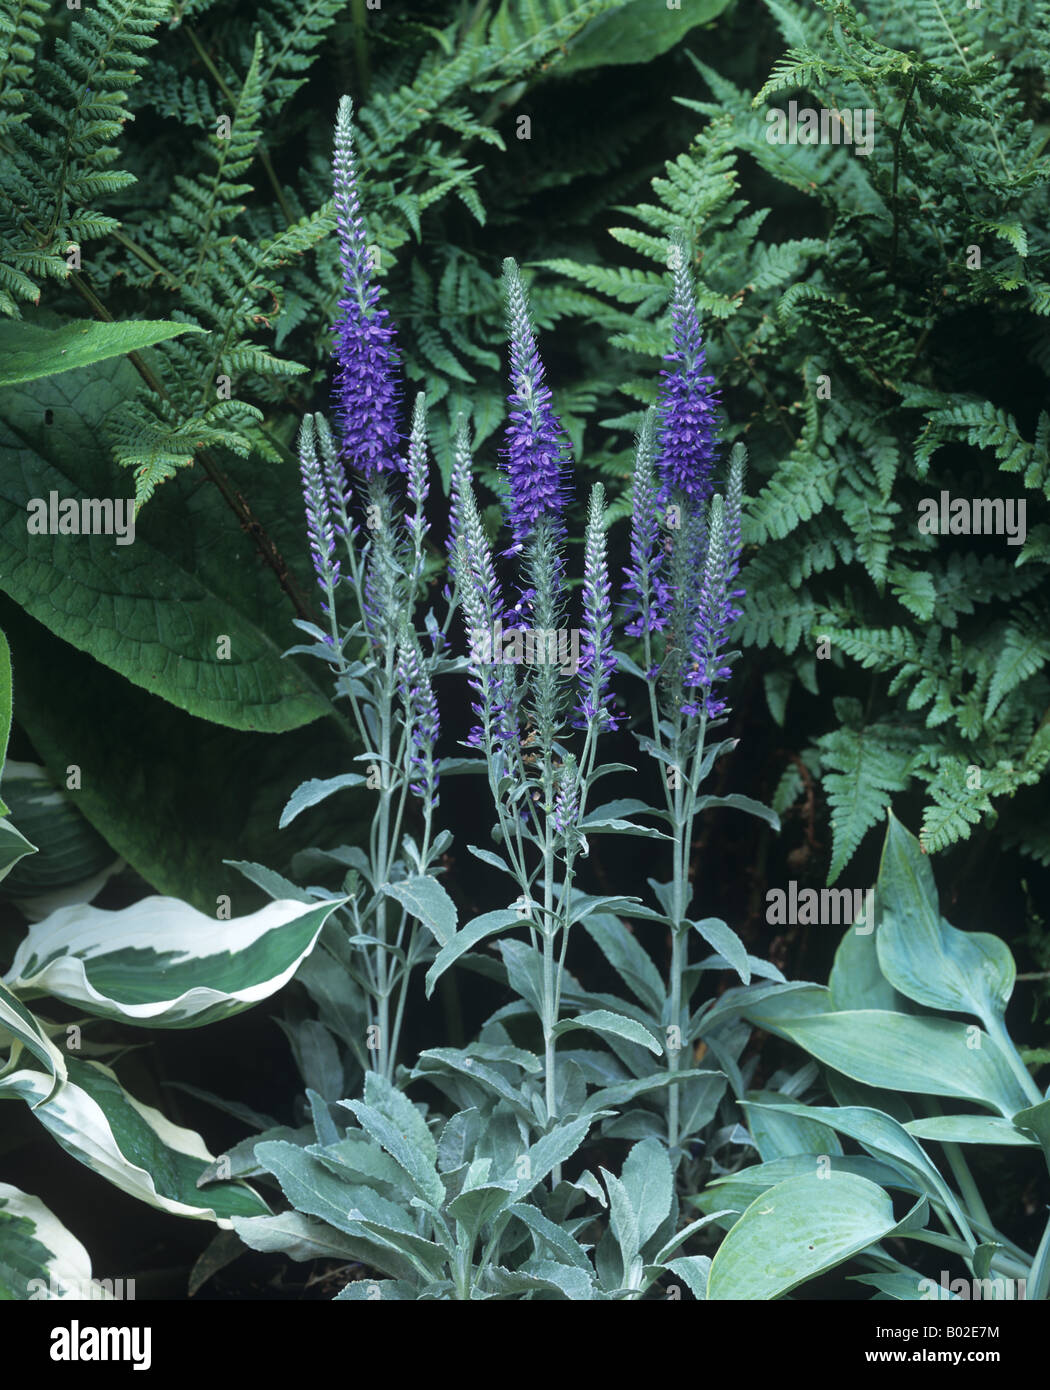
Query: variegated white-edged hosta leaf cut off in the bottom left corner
0,1183,104,1302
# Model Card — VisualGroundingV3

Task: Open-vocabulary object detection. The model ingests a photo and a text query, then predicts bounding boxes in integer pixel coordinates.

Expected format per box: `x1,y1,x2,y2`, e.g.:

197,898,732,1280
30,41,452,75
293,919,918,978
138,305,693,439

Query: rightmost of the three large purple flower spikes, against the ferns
656,232,718,502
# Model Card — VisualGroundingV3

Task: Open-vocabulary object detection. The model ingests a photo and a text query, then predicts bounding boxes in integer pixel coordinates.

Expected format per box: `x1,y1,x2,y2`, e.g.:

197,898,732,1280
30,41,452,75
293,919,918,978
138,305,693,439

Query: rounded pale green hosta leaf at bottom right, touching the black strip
706,1169,926,1301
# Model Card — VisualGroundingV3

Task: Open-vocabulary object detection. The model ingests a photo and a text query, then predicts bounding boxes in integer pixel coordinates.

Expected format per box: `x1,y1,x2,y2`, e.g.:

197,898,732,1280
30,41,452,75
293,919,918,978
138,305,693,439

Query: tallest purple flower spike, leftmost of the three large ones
332,96,405,477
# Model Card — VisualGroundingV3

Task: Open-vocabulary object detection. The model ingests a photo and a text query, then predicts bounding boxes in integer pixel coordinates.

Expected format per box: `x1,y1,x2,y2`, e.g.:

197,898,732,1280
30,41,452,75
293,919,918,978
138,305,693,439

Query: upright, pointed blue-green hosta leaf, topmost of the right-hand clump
875,815,1017,1029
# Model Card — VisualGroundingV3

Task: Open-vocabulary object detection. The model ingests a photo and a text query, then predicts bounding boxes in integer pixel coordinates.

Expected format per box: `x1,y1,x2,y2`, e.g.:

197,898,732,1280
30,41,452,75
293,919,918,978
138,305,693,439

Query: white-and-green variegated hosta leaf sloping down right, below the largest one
0,1058,270,1230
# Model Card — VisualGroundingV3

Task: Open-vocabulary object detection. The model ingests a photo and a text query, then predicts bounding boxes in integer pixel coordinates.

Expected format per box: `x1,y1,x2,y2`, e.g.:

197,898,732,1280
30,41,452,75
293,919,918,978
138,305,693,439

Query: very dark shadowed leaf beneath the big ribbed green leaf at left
0,597,361,915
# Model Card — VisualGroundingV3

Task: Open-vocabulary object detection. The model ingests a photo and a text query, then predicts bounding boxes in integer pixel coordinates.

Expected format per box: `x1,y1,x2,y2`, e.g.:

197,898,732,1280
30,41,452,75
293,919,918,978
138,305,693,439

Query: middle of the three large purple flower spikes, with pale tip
501,259,570,555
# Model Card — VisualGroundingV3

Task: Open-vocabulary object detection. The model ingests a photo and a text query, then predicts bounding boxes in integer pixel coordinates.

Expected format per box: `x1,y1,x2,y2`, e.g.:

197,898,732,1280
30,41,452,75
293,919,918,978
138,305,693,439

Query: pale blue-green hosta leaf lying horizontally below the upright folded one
767,1009,1026,1116
